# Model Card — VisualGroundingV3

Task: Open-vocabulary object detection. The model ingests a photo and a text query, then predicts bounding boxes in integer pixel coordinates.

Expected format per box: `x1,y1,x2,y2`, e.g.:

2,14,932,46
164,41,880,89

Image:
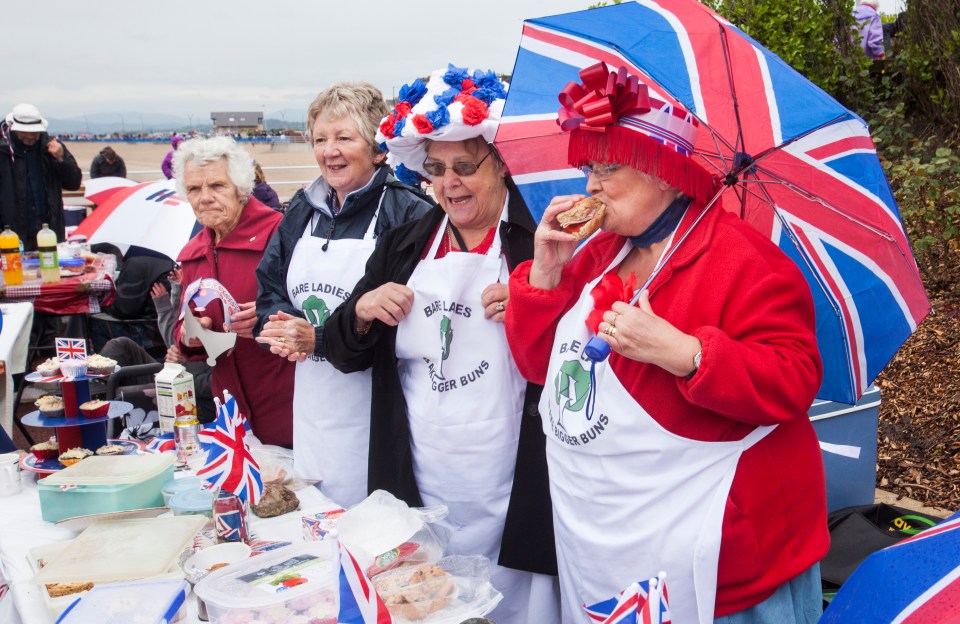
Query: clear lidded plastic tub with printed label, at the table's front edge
194,540,340,624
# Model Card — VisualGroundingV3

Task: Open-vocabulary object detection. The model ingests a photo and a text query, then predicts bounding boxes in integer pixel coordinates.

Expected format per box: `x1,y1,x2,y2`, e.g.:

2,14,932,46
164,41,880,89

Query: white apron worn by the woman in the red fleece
540,242,774,624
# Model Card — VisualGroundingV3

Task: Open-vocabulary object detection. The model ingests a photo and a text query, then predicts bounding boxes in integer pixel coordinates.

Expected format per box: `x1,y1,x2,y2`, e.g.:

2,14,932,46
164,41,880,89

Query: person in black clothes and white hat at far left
0,104,83,251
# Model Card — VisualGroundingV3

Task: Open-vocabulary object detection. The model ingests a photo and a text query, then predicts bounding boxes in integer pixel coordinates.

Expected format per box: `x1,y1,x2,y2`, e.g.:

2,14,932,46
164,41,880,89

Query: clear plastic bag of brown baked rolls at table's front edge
371,555,503,624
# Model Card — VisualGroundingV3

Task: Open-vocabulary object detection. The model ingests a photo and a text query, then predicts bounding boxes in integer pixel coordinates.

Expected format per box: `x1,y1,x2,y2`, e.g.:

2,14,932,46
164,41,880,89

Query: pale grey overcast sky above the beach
0,0,902,121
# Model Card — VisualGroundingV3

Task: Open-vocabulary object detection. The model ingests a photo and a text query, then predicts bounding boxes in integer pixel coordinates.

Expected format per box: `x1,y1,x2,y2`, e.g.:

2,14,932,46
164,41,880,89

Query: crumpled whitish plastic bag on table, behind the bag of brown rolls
337,490,450,577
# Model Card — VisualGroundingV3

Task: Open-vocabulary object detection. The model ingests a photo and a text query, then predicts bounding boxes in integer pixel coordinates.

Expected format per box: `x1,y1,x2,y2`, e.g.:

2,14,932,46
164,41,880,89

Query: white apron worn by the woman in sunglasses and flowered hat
396,210,559,624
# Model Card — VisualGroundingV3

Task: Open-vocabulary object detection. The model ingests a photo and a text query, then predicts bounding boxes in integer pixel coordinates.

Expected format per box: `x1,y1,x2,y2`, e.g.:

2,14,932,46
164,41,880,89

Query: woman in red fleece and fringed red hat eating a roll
505,63,829,623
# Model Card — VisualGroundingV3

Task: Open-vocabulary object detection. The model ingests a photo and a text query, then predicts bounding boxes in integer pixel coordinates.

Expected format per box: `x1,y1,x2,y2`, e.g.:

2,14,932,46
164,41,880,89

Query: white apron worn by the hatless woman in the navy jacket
287,204,383,508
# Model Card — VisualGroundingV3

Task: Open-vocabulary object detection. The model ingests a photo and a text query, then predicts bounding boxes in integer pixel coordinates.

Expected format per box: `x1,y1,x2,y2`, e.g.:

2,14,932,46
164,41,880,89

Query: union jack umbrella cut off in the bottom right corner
820,513,960,624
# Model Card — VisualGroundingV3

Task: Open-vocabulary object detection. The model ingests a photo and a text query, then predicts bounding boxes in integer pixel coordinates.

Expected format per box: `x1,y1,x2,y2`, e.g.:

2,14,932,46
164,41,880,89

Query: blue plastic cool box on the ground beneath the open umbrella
808,386,880,511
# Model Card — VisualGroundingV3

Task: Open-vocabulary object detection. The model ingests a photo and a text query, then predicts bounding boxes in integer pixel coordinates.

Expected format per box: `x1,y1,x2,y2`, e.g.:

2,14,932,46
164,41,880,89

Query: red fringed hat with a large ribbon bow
557,62,717,203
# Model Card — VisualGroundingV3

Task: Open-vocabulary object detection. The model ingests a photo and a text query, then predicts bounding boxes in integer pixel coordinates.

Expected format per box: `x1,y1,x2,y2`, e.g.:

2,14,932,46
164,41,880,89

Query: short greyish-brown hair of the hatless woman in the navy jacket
307,82,390,156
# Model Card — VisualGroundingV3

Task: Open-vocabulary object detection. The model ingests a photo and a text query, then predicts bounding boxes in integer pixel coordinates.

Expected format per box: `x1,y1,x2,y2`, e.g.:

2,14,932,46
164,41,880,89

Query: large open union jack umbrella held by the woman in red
495,0,930,404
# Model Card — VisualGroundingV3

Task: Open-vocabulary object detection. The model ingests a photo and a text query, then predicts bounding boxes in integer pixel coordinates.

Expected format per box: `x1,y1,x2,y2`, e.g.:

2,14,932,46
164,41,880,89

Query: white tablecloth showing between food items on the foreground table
0,468,337,624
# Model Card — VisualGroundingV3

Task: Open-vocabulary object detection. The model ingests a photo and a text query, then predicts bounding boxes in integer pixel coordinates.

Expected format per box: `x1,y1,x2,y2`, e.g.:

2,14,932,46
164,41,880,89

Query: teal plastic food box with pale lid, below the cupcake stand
37,453,176,522
